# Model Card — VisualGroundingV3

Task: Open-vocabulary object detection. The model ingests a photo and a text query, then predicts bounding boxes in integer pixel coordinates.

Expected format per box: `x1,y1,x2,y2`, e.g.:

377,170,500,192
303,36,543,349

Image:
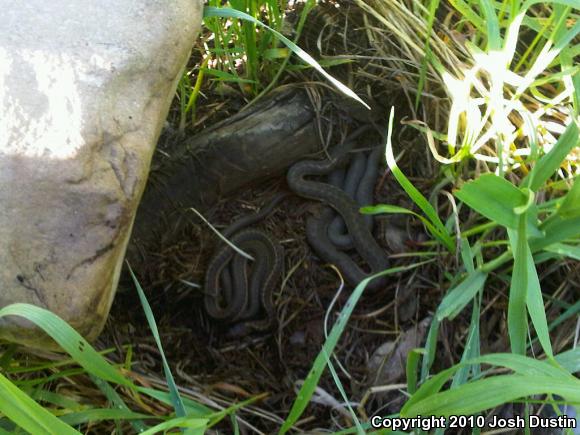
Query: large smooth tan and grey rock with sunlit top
0,0,202,346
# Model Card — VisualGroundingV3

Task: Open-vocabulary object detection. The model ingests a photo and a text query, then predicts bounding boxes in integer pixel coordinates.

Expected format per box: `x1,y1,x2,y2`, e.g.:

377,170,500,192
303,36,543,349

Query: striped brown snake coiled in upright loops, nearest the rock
204,192,287,332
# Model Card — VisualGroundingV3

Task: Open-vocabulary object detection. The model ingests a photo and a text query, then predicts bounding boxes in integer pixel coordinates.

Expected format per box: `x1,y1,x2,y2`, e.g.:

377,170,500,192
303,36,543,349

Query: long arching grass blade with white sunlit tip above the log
203,6,370,110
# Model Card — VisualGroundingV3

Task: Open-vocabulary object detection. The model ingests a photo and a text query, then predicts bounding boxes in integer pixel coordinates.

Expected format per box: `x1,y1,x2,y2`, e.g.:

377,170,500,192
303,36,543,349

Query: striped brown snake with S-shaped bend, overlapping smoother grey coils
286,127,388,290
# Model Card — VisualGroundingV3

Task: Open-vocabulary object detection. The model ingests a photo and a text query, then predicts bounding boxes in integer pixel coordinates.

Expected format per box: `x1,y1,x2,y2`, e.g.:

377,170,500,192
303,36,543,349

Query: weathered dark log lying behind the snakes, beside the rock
128,90,320,252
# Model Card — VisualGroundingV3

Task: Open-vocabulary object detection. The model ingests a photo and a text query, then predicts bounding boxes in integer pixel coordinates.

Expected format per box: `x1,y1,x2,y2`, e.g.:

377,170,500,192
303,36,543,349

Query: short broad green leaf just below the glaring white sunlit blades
455,174,527,229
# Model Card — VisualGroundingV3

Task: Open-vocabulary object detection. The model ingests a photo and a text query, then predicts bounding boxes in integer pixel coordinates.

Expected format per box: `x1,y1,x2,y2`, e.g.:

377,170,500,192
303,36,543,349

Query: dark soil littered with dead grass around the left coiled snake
101,125,448,433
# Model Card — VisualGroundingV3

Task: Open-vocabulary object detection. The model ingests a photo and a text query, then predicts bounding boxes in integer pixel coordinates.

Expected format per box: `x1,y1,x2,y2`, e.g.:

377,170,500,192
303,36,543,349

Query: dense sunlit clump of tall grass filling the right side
359,0,580,430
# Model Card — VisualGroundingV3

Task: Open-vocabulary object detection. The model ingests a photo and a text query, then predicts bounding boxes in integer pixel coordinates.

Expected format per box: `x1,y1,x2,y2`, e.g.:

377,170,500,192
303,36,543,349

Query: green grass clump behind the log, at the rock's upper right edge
178,0,316,129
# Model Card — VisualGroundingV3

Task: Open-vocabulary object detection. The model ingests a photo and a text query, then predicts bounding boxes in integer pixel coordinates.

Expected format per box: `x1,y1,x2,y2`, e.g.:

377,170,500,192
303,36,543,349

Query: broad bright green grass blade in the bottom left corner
0,374,80,435
